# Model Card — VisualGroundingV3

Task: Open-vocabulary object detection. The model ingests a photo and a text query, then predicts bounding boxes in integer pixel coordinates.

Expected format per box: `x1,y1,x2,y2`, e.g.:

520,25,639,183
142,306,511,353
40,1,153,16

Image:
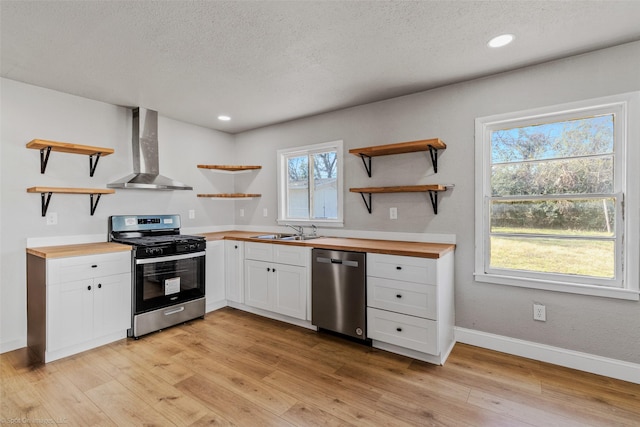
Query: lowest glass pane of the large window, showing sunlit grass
491,236,615,279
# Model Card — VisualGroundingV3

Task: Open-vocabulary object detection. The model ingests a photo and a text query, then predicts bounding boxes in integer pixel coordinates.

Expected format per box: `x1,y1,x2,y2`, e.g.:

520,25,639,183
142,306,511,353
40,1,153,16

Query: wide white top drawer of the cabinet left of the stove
47,252,132,285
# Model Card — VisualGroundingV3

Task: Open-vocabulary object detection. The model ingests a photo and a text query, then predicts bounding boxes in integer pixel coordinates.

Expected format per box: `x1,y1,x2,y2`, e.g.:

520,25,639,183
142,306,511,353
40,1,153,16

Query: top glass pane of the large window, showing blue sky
491,114,613,163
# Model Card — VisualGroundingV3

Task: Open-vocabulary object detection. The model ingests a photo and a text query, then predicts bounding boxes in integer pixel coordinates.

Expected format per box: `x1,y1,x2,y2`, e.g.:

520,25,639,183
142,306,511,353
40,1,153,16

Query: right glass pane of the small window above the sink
311,151,338,219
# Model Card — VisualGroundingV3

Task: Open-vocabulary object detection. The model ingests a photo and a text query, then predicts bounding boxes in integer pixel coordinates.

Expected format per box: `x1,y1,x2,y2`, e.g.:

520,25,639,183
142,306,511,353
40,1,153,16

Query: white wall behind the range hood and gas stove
0,79,233,351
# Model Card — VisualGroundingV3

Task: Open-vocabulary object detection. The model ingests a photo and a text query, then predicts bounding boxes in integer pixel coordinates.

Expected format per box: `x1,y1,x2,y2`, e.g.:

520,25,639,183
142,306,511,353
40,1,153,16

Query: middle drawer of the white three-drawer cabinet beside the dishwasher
367,277,438,320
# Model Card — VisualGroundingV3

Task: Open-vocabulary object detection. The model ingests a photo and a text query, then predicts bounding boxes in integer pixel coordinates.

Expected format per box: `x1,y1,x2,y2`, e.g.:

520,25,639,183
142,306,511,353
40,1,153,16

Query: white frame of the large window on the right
474,92,640,300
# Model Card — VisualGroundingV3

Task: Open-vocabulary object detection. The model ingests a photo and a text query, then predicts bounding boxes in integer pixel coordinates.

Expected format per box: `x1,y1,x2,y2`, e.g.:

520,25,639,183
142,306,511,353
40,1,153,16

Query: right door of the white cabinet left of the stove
93,273,131,338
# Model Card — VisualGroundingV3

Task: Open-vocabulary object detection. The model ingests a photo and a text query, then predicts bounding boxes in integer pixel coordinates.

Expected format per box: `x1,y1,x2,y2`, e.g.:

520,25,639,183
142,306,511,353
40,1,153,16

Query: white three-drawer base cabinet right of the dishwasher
367,252,455,364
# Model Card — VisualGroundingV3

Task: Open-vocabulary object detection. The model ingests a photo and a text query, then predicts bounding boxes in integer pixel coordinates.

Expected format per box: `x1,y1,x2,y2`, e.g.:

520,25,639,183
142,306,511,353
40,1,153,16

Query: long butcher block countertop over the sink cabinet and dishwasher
200,231,456,259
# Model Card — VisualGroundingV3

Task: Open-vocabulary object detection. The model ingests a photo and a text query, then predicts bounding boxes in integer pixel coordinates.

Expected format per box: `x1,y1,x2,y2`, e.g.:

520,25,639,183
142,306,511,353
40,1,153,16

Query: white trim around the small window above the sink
276,140,344,227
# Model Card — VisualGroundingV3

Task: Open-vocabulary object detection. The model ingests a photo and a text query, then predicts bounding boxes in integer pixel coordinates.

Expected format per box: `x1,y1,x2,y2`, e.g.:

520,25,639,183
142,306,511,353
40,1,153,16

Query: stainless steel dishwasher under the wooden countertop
311,249,367,340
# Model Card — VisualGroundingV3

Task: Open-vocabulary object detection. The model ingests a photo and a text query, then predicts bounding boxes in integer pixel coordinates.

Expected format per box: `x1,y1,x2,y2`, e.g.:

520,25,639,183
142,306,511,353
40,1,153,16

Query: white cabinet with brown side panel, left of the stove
27,252,132,362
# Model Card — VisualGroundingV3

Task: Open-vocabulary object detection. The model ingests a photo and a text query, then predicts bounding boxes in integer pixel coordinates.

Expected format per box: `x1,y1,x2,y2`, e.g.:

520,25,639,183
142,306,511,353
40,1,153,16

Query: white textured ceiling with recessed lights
0,0,640,133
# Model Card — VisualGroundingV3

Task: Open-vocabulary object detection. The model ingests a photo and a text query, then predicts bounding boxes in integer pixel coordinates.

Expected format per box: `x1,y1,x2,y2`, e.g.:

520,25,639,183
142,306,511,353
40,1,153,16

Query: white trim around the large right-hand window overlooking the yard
474,92,640,301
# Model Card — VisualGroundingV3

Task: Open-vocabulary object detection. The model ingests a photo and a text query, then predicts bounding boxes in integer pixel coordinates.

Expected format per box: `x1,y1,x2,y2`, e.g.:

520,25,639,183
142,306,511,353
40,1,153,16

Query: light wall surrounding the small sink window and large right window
236,43,640,363
